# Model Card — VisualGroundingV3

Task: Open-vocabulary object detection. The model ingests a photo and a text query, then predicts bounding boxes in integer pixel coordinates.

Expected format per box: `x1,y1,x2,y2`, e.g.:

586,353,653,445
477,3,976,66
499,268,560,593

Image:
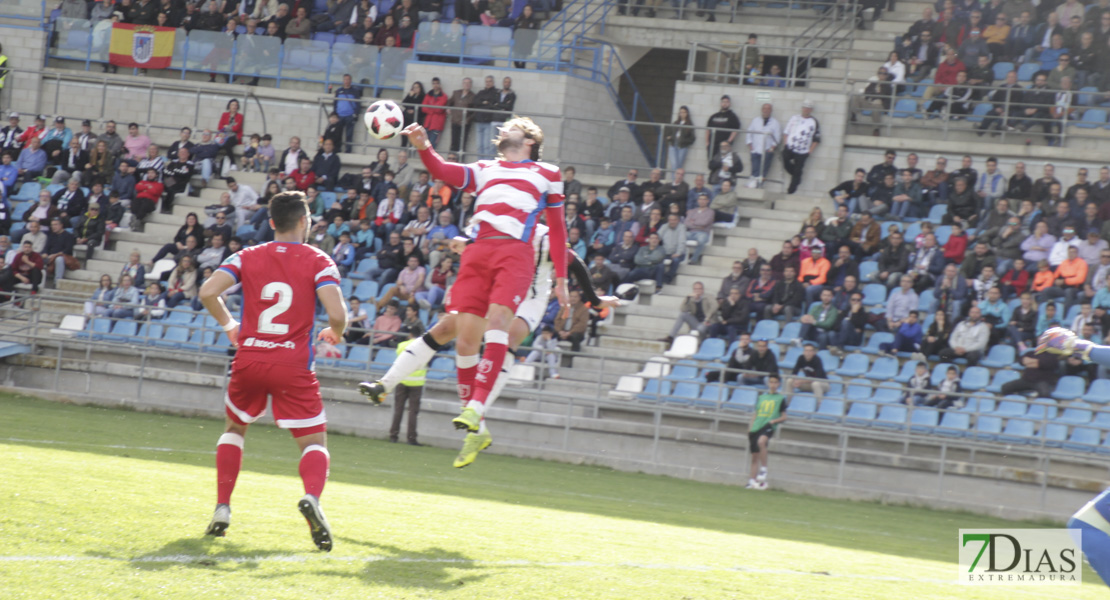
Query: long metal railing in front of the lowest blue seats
0,294,1104,509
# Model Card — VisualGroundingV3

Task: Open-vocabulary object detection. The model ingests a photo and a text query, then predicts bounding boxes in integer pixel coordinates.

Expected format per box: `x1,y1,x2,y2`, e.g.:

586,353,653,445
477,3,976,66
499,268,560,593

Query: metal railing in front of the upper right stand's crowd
848,82,1107,145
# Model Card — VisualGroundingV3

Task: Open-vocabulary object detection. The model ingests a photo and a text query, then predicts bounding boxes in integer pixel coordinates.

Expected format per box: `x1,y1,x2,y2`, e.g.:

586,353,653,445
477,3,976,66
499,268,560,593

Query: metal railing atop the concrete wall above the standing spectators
686,42,850,91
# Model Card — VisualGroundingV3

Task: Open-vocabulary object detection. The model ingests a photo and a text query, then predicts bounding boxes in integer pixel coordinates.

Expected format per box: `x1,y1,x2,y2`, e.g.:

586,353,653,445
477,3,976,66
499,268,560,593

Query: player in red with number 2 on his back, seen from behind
200,192,346,551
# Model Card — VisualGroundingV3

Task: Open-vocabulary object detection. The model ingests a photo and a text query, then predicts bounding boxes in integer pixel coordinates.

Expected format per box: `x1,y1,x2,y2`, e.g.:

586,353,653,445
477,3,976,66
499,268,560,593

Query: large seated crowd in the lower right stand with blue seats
665,151,1110,401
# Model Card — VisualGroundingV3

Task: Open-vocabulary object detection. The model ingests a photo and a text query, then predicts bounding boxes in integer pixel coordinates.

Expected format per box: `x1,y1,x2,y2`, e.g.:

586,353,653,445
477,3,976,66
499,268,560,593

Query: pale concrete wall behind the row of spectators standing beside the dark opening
669,81,848,194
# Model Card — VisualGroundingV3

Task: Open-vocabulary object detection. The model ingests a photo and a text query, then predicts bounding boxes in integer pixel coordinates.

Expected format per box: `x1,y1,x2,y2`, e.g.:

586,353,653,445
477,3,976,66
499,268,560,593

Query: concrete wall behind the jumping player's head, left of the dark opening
405,62,647,174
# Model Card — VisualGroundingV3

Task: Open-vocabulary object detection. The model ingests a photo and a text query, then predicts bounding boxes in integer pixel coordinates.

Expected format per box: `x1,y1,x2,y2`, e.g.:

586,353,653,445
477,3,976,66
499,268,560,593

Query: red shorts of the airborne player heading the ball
446,240,536,318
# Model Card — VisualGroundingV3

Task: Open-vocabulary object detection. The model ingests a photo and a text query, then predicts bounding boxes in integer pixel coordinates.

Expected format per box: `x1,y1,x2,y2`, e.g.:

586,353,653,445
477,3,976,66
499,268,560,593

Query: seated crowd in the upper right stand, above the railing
851,0,1110,145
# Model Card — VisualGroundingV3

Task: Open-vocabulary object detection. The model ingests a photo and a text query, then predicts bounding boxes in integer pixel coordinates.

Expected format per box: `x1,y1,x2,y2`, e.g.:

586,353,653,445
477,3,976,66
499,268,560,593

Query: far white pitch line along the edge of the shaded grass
0,437,937,541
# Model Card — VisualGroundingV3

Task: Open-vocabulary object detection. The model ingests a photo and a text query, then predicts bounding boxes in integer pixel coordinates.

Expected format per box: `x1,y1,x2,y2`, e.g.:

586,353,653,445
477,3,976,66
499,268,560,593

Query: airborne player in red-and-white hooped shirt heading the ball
402,116,567,433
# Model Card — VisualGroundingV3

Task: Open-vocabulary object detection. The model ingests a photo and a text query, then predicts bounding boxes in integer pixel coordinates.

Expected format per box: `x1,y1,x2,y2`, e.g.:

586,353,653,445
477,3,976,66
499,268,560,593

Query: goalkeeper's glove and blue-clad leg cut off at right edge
1037,327,1110,584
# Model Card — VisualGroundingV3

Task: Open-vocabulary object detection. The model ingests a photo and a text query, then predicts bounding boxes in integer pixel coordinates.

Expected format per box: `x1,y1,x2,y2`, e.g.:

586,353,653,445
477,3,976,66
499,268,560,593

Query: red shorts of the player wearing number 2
223,359,327,433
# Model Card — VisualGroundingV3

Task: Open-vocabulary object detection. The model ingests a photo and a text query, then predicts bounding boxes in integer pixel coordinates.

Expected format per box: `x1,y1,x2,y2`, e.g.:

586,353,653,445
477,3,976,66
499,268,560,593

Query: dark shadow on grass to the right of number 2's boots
339,537,501,590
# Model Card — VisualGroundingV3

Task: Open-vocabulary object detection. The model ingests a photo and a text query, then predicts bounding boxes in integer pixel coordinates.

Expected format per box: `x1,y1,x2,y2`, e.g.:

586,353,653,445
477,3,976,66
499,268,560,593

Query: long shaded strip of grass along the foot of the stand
0,396,1013,565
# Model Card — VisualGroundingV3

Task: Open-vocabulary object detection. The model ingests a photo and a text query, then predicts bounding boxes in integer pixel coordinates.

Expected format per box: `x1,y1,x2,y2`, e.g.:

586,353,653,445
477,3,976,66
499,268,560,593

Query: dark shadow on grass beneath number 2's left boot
114,536,297,572
